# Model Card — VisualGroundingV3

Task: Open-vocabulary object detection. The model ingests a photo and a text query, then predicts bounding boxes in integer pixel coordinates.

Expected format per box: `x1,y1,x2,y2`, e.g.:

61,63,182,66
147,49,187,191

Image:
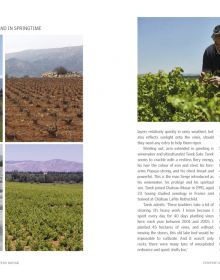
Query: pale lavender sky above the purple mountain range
5,144,83,162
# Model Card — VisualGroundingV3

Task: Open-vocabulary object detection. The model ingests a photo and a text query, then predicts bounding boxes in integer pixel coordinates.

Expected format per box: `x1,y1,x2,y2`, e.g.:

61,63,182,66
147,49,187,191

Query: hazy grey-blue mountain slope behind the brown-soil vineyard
5,46,83,78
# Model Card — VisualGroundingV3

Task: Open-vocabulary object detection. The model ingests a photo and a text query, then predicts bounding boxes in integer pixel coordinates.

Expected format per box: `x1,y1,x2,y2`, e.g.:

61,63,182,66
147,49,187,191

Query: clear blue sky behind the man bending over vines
138,17,220,74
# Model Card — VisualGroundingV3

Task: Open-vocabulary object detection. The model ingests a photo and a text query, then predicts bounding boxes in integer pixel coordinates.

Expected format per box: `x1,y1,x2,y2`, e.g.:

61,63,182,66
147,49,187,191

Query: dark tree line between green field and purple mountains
5,171,83,184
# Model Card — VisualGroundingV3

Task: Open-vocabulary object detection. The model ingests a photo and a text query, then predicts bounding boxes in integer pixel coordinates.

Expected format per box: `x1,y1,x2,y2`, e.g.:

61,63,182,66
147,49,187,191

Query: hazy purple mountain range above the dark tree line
5,159,83,172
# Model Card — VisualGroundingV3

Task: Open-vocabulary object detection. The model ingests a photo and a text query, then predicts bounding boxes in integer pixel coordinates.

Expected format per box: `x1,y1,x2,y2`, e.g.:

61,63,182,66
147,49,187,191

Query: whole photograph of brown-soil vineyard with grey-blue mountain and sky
4,35,83,142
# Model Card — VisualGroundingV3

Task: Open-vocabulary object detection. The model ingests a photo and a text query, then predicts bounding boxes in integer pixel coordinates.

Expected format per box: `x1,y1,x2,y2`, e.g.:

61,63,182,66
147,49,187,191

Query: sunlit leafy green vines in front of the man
138,67,220,122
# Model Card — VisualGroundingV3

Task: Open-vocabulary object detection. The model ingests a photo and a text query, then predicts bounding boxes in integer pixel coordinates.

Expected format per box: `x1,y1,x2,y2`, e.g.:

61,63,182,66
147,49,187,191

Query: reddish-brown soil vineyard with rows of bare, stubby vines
5,77,83,142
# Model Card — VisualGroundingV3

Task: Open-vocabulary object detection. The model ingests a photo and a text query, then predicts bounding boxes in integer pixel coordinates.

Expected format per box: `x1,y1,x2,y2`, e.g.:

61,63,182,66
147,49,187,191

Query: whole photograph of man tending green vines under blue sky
137,17,220,122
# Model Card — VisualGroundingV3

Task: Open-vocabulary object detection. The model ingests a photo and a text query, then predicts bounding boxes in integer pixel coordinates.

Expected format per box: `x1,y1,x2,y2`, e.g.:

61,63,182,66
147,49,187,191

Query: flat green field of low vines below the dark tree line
5,182,83,251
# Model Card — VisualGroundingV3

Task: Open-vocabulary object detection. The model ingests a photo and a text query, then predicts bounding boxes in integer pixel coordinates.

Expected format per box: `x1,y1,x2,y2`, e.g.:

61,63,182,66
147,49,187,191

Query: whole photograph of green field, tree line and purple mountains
5,144,83,251
